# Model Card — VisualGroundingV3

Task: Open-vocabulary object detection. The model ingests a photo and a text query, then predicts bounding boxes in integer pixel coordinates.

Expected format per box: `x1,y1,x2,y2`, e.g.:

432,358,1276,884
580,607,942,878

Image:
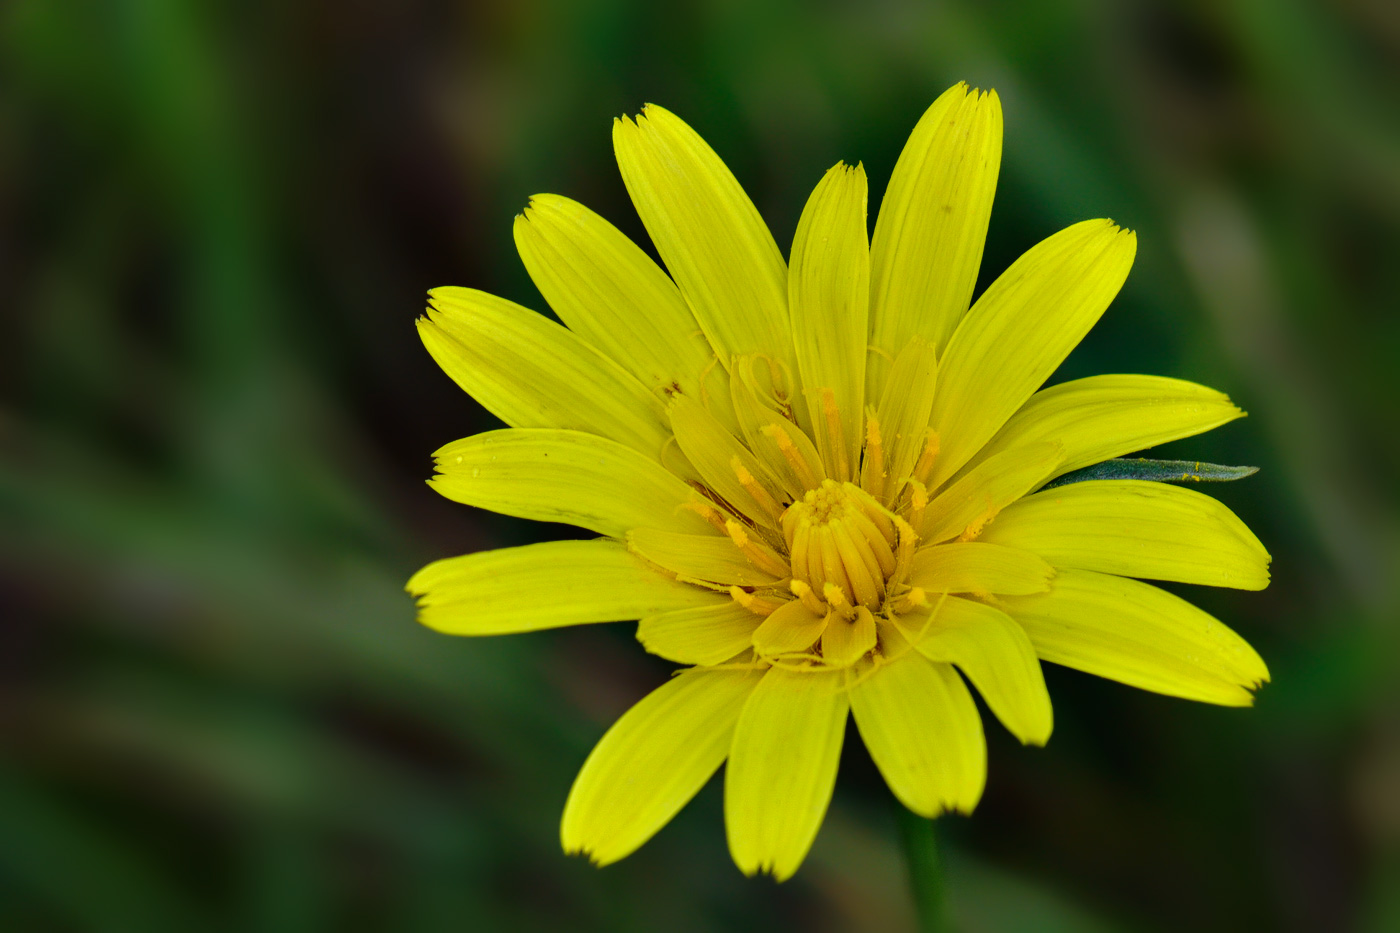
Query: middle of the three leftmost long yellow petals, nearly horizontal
430,427,715,538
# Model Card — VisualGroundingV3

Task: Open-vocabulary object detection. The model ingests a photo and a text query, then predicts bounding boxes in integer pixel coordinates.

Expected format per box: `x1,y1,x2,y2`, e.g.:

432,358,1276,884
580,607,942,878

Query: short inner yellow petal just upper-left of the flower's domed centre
669,395,781,528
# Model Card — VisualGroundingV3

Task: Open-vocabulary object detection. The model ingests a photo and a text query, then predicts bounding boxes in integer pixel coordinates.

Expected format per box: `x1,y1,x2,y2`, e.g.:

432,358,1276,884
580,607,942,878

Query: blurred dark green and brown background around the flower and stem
0,0,1400,932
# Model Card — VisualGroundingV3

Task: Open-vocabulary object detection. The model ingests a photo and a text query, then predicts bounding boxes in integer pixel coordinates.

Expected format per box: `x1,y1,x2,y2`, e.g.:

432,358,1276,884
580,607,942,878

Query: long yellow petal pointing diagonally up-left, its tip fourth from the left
515,195,734,424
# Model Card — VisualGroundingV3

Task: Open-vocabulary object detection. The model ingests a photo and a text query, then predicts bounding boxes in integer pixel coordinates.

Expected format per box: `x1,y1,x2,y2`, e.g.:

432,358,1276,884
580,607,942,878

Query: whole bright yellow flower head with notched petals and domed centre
409,84,1268,878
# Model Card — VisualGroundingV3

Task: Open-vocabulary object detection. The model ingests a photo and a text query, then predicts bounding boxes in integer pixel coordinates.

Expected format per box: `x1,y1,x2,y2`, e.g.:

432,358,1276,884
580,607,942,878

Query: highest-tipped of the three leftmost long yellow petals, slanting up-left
419,282,671,459
